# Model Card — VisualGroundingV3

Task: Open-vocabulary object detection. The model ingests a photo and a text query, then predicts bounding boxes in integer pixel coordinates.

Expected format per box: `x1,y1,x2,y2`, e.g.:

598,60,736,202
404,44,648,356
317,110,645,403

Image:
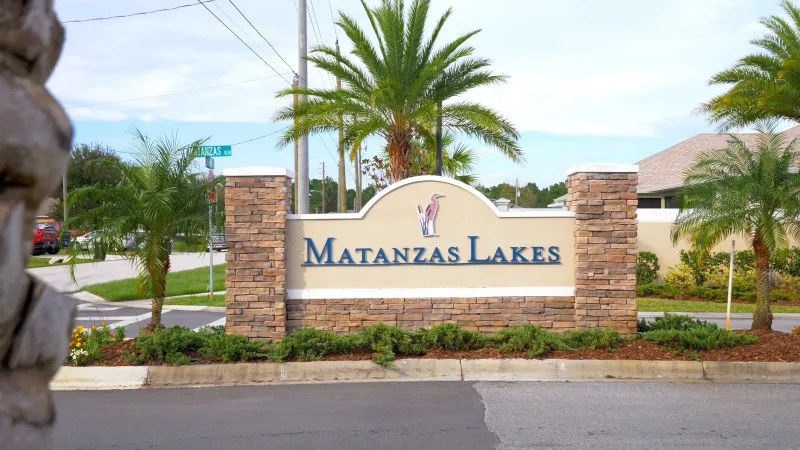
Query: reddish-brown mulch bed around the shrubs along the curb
75,331,800,366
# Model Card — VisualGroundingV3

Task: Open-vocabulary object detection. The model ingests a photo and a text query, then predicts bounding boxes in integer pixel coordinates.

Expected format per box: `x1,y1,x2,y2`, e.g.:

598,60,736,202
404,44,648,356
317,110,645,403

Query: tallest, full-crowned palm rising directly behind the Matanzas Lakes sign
275,0,523,181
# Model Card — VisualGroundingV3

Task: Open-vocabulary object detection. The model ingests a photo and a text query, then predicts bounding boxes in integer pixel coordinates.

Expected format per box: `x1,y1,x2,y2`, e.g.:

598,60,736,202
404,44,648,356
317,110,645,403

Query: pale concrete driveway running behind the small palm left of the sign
28,252,225,292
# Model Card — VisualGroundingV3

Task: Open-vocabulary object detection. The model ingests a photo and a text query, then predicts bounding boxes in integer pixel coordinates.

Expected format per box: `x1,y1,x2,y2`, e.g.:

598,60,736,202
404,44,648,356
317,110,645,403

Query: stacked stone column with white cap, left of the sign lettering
224,167,294,340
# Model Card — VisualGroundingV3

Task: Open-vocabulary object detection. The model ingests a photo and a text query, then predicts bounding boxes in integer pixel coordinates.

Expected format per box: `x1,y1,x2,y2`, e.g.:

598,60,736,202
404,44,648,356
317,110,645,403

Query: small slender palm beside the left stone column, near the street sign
68,130,220,332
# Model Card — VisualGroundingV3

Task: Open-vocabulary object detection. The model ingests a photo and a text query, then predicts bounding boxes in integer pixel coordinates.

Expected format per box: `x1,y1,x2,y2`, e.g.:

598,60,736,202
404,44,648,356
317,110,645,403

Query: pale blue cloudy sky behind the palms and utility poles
49,0,779,186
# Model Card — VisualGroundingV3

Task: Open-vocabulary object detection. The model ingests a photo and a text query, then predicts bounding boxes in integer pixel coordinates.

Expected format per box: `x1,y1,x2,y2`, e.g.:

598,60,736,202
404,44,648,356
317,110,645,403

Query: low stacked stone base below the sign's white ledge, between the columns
286,297,576,333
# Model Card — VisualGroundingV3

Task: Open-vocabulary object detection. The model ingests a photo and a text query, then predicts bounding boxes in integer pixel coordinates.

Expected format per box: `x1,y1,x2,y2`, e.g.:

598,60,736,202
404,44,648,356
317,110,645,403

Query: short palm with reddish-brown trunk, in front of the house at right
672,119,800,330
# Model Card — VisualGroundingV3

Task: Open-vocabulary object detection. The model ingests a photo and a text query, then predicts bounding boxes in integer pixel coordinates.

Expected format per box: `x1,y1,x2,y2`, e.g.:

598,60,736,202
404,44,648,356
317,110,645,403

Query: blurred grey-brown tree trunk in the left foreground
0,0,74,449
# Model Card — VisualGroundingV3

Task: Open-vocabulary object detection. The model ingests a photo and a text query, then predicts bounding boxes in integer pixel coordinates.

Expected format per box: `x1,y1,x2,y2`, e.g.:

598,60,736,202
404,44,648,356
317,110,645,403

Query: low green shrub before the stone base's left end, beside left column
266,328,354,361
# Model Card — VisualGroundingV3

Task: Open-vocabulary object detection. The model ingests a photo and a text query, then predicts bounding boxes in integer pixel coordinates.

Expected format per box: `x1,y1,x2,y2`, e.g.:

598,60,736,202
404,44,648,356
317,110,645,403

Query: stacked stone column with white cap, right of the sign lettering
566,164,639,334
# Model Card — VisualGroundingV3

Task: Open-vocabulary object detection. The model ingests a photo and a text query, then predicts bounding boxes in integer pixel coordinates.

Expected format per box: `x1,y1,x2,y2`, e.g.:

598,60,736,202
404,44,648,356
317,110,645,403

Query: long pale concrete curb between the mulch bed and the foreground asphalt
51,359,800,390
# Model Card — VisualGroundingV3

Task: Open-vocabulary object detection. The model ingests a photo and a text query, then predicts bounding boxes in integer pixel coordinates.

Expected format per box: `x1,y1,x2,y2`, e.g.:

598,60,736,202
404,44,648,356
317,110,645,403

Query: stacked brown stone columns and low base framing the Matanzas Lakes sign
225,166,637,340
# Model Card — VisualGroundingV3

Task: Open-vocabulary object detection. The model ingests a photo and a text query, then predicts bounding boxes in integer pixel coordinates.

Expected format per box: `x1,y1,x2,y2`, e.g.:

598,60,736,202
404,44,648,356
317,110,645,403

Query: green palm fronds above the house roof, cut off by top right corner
699,0,800,130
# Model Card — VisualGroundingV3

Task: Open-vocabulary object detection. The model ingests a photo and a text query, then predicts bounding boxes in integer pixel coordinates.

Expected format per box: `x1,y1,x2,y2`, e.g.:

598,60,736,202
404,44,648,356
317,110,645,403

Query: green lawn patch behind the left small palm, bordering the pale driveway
83,264,226,304
